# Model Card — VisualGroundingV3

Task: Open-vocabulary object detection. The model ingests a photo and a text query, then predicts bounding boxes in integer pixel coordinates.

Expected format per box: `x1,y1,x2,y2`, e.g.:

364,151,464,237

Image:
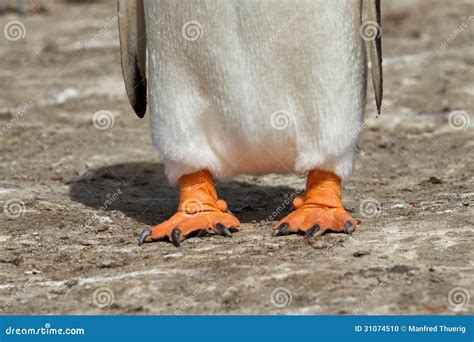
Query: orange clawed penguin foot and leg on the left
138,170,240,247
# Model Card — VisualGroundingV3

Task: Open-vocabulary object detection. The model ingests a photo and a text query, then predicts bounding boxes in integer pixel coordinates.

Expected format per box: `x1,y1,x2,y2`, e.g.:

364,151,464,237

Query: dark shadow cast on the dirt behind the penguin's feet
70,163,297,225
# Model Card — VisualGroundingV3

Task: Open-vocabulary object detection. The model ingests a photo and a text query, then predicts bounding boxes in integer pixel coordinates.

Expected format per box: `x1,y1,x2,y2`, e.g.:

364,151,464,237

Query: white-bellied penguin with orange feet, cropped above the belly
118,0,383,246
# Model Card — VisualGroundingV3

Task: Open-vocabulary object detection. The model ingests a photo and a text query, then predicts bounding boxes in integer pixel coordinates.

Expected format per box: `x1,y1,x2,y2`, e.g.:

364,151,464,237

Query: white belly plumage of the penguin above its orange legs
145,0,366,182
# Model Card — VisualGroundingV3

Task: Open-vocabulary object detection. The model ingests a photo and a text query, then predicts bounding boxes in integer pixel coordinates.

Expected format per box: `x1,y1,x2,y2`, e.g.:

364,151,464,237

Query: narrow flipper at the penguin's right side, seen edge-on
369,0,383,114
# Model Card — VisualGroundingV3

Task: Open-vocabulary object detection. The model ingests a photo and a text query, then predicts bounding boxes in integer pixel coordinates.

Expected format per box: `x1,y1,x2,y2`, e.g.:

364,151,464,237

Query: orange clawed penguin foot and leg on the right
273,170,359,238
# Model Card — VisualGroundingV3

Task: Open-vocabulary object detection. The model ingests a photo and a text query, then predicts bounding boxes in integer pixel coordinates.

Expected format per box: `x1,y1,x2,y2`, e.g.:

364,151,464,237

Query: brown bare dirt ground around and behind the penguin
0,0,474,315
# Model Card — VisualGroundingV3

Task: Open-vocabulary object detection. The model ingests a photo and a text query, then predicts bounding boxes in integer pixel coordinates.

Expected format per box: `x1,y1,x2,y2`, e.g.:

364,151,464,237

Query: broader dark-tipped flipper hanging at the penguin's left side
118,0,147,118
